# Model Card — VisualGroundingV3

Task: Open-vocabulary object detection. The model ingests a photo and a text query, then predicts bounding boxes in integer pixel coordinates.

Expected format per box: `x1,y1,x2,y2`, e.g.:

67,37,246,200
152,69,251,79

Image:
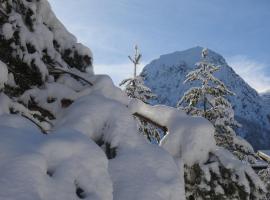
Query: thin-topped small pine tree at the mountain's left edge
119,45,161,143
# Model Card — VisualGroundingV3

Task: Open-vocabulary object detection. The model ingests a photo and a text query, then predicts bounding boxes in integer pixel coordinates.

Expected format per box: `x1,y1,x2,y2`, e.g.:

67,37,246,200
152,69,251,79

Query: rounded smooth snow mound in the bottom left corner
0,118,112,200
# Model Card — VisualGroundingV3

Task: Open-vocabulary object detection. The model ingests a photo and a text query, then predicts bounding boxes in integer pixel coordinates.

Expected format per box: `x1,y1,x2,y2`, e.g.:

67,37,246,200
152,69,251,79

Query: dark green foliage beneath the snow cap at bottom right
184,155,264,200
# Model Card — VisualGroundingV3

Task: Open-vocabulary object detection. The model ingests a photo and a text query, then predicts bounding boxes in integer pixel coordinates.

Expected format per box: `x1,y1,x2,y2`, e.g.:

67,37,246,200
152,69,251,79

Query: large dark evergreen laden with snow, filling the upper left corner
0,0,92,132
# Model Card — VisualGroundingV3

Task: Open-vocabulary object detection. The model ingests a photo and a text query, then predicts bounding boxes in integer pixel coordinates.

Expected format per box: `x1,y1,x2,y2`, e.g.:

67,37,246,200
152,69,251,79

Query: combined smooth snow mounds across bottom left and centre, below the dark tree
0,76,185,200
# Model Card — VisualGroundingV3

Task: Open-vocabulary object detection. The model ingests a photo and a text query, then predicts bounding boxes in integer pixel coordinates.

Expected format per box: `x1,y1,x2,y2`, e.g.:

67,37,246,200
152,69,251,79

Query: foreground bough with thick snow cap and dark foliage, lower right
130,100,266,200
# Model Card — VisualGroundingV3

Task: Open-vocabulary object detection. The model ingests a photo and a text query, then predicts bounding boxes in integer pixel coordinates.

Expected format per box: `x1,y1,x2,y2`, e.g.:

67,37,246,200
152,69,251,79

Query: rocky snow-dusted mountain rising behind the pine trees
141,47,270,149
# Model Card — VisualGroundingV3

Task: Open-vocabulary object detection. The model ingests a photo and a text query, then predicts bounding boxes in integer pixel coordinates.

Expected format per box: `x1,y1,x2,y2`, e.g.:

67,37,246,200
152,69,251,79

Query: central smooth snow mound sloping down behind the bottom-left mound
55,91,184,200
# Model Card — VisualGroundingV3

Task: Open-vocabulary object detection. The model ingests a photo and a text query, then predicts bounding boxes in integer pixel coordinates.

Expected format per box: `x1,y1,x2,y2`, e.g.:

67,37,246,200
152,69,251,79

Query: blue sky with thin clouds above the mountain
49,0,270,92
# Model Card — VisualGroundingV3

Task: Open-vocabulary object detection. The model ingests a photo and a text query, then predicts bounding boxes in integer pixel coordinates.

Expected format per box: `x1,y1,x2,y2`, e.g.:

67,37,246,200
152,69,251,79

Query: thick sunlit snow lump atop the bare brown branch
129,100,216,166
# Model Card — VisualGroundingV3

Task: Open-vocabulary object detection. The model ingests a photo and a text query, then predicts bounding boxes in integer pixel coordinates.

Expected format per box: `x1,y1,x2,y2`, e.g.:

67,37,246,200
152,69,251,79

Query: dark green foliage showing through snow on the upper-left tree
0,0,92,97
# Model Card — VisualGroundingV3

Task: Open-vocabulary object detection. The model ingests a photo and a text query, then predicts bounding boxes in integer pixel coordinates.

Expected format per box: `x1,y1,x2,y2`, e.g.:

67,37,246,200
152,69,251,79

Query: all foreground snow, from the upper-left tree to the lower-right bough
0,0,266,200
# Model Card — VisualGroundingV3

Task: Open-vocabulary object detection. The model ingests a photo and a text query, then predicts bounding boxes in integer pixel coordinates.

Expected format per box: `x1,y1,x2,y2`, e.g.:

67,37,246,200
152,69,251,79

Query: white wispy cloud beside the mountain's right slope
227,55,270,92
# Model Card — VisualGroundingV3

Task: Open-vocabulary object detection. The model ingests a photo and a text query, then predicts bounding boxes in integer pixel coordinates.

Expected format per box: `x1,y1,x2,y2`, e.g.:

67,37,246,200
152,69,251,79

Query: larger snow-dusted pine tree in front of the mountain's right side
177,49,256,163
